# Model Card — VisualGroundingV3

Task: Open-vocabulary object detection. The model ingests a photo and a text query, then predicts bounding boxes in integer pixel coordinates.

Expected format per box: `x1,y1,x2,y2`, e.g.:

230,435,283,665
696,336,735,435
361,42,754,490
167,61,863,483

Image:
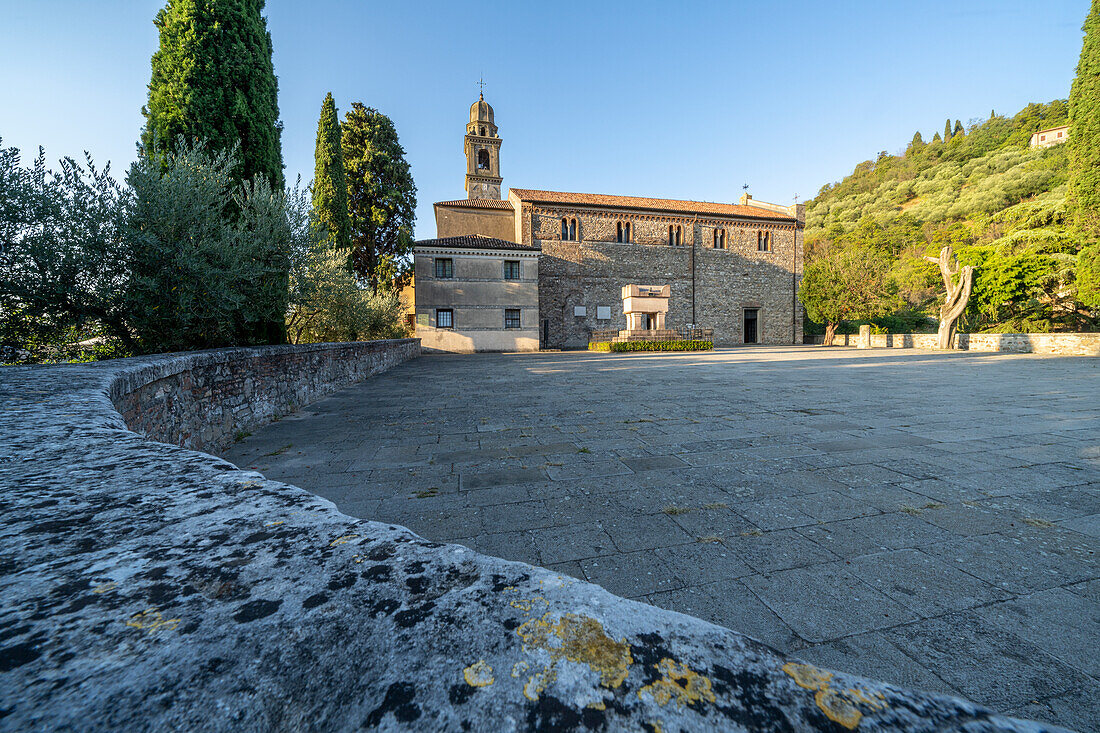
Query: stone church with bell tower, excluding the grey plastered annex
431,98,805,349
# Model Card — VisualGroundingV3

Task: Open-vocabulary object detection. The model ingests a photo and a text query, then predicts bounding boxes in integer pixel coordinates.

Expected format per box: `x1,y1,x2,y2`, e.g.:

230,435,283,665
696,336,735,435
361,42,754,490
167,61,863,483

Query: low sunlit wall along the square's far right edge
805,333,1100,357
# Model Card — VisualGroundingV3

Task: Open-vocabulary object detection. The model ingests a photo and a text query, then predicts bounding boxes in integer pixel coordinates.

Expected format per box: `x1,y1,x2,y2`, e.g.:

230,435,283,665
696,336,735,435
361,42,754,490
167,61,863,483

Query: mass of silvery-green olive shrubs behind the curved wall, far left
0,140,295,361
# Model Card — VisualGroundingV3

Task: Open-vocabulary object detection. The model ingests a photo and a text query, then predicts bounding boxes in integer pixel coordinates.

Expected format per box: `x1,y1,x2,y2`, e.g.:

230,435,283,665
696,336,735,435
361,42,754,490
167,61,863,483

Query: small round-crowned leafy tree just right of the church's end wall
799,239,894,346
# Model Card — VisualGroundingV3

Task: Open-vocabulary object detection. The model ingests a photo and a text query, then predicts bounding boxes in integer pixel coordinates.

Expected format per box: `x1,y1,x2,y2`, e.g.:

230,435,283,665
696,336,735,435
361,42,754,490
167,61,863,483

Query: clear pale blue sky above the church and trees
0,0,1089,238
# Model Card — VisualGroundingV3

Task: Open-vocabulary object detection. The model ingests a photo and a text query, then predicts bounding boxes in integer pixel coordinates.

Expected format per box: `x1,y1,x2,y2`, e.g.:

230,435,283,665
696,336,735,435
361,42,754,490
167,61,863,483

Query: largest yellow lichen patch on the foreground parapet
516,613,634,689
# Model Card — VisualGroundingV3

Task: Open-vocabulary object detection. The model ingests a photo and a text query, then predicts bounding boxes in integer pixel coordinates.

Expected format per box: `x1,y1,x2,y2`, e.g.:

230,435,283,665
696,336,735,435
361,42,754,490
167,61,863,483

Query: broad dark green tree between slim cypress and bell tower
342,102,416,291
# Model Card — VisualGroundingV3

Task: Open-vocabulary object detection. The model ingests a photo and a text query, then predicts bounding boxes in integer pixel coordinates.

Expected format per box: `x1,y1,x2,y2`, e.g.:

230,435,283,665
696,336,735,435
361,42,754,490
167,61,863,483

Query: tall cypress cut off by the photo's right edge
1066,0,1100,234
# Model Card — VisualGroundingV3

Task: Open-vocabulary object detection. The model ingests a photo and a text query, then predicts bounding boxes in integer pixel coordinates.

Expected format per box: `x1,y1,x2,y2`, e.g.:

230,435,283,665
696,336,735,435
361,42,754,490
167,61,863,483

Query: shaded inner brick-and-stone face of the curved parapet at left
111,339,420,450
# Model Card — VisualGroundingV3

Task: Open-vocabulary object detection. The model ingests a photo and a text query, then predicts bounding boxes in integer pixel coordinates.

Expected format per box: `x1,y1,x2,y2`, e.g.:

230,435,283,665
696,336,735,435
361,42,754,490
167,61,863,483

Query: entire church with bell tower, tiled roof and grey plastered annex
414,91,805,351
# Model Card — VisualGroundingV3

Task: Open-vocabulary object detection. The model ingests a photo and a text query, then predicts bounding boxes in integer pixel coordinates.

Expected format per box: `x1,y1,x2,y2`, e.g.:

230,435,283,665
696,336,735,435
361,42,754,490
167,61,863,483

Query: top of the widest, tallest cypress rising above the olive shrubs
141,0,284,189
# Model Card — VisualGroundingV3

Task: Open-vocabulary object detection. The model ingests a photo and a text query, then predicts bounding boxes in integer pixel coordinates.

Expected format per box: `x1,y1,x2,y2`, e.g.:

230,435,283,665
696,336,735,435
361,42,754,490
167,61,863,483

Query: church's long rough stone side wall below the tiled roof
521,206,802,348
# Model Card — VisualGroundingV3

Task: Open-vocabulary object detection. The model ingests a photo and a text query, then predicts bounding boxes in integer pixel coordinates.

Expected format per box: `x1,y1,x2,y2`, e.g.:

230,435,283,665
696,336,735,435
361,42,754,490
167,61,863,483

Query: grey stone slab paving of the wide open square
216,347,1100,731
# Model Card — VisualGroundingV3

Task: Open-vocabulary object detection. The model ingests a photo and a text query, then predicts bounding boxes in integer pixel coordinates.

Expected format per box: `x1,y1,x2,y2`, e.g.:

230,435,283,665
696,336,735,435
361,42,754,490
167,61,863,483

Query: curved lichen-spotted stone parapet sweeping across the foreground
0,342,1052,732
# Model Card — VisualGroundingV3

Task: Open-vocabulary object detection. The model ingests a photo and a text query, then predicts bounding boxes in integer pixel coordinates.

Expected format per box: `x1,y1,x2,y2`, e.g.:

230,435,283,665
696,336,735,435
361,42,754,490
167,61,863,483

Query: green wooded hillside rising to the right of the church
805,100,1097,331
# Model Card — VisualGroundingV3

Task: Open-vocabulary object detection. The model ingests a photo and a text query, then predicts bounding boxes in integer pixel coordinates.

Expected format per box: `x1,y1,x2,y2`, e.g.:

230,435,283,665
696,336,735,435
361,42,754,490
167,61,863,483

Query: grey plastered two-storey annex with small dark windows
413,237,539,353
